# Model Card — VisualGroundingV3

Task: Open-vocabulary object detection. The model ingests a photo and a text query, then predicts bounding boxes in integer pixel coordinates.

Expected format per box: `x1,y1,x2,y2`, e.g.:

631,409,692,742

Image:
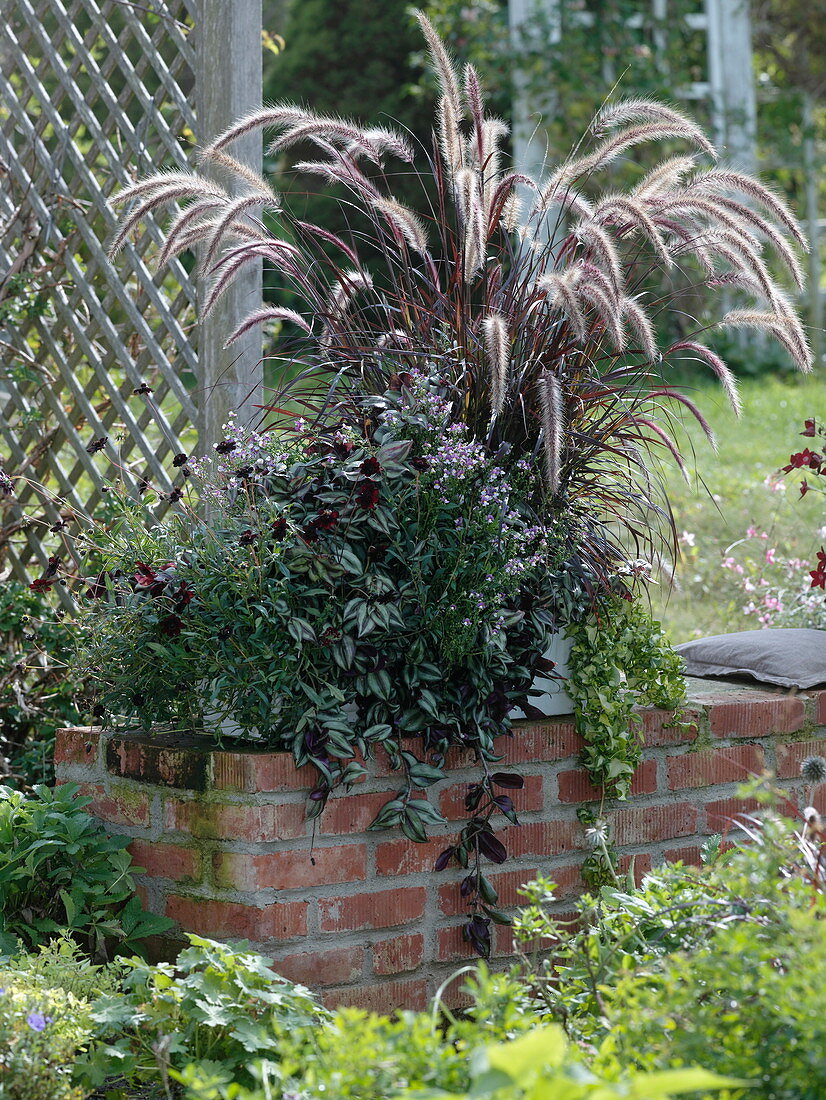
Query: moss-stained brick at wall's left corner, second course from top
164,799,310,844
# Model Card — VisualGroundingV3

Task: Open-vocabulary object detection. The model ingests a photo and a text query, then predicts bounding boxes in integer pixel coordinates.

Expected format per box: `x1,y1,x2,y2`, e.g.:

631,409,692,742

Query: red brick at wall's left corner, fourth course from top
166,894,307,944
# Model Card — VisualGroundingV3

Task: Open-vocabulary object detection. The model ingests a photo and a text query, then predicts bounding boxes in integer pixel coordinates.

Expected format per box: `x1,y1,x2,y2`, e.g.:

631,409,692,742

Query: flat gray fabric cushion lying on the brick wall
674,628,826,688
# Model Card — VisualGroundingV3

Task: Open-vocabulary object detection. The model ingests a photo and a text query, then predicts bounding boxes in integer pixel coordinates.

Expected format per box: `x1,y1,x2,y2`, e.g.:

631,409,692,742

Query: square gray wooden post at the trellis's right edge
196,0,263,452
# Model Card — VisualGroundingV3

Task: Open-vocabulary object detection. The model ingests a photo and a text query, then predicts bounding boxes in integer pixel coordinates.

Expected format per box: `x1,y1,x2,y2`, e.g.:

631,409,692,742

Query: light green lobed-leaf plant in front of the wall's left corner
76,935,328,1093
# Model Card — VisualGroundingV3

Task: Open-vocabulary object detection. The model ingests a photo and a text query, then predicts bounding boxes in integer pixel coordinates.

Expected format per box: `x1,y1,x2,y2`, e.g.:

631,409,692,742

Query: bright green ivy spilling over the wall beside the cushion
566,594,685,799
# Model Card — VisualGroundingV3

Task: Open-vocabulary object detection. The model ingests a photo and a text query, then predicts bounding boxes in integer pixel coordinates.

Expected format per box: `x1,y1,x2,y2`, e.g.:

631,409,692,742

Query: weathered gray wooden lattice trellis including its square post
0,0,261,598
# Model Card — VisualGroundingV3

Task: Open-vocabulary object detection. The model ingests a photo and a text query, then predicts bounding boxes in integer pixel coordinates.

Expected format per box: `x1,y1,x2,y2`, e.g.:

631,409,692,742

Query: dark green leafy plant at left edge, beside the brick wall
0,783,172,955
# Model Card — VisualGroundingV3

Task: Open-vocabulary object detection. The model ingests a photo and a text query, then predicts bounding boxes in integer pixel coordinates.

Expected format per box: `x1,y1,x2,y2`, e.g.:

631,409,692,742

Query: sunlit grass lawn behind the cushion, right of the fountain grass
651,371,826,642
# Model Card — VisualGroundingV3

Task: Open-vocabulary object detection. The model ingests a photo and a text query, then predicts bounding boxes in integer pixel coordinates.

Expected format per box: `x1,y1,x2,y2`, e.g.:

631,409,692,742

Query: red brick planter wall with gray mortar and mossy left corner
56,680,826,1011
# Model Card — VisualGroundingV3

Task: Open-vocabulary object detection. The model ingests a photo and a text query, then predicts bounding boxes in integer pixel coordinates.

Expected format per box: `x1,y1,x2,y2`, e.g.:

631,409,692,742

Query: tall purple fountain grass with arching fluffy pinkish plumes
112,14,811,584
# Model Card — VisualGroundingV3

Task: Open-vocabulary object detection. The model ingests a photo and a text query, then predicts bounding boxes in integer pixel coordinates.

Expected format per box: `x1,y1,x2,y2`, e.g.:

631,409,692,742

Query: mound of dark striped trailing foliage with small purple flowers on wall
79,373,570,950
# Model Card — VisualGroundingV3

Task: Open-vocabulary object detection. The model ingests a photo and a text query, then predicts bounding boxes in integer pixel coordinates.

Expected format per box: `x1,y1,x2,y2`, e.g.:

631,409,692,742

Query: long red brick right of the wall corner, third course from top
212,844,367,891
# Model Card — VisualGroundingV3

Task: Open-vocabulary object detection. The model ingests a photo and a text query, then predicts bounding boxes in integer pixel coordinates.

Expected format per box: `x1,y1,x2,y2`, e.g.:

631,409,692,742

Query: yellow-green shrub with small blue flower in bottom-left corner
0,971,91,1100
